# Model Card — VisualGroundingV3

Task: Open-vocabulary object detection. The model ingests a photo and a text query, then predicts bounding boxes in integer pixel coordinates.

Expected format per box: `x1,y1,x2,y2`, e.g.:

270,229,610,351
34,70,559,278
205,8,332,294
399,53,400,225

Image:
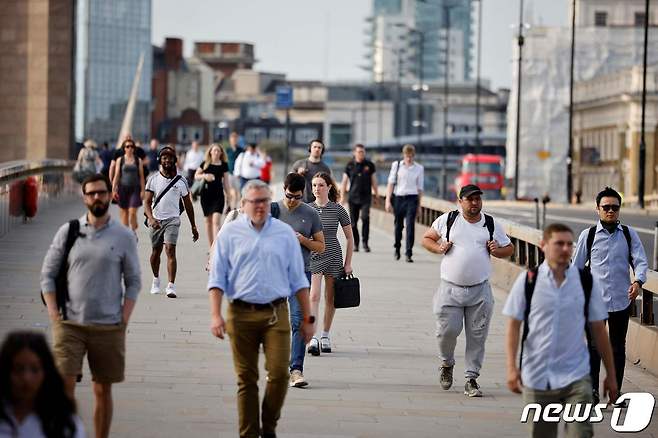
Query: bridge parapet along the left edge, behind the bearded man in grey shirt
0,159,80,237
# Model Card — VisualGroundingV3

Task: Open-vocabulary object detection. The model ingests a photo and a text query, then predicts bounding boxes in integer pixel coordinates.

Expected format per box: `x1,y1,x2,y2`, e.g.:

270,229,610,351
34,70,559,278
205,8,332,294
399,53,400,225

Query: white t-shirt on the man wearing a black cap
432,212,512,286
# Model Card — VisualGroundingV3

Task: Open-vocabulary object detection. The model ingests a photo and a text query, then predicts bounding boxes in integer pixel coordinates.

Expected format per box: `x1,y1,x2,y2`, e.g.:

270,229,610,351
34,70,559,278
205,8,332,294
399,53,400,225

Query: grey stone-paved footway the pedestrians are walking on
0,198,658,438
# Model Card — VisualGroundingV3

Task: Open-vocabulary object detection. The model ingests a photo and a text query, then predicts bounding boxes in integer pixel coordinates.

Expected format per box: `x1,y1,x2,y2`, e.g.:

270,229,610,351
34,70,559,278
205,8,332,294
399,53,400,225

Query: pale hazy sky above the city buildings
152,0,570,88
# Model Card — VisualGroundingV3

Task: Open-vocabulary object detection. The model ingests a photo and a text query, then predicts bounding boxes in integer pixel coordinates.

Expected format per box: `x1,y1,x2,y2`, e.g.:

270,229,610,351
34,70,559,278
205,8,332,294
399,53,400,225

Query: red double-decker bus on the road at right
455,154,505,200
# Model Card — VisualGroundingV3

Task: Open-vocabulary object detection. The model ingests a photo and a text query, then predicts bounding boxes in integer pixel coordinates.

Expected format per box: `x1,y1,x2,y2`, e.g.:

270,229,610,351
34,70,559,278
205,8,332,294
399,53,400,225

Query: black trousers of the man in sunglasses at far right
587,304,631,391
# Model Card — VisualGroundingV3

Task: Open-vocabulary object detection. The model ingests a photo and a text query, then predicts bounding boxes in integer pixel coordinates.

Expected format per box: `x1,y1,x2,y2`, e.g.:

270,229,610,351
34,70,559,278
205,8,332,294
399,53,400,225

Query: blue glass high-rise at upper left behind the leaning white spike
75,0,152,142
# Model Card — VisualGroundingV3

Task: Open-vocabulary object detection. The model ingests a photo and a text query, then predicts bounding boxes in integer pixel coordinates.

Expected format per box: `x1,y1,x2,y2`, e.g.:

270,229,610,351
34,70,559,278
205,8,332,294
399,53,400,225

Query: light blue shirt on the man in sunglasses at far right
573,221,649,312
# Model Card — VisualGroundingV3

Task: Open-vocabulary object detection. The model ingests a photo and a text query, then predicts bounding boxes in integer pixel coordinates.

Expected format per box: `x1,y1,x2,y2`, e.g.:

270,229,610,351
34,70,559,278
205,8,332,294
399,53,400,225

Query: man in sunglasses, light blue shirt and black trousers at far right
573,187,649,401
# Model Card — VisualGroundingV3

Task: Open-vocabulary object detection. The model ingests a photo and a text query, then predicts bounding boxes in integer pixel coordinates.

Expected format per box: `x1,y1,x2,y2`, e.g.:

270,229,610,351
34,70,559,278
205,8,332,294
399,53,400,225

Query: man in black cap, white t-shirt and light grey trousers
423,184,514,397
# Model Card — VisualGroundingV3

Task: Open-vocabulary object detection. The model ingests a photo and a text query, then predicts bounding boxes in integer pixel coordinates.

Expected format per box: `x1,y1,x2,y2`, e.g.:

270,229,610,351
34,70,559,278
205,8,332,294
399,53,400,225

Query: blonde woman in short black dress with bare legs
194,144,230,246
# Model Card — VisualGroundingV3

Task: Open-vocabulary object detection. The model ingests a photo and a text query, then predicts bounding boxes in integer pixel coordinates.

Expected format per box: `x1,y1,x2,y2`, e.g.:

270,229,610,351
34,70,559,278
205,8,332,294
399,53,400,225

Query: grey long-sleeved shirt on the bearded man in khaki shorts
41,215,141,325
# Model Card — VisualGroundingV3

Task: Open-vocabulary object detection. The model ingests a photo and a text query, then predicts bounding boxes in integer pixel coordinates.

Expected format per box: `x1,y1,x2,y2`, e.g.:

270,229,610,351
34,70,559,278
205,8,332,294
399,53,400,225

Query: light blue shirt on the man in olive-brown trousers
208,214,309,304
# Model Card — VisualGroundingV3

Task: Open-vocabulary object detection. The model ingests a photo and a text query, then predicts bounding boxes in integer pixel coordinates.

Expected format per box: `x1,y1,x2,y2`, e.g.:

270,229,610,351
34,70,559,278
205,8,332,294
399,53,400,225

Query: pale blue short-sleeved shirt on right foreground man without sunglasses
503,262,608,390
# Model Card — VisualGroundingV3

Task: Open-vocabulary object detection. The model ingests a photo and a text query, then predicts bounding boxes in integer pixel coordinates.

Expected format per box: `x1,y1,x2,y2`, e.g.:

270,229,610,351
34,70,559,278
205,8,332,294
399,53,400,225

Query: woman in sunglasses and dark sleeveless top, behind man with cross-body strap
112,140,145,236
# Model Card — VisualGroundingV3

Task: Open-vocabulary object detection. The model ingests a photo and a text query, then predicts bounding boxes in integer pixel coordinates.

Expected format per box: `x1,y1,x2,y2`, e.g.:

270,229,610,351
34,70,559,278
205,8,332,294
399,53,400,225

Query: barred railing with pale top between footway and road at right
375,186,658,326
